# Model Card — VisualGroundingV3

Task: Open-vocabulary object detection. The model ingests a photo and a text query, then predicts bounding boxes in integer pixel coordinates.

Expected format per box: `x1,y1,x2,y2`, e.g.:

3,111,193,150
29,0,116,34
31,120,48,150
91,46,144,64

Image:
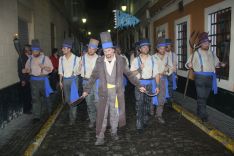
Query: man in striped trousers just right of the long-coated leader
131,39,159,134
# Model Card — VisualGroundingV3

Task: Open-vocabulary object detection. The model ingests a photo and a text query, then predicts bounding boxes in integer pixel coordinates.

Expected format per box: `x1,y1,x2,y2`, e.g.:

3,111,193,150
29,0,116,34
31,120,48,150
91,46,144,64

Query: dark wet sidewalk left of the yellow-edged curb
0,93,61,156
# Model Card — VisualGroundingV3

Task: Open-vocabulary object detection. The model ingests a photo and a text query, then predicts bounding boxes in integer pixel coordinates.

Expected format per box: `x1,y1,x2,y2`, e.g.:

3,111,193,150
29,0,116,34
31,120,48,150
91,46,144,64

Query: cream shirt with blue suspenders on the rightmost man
185,49,219,72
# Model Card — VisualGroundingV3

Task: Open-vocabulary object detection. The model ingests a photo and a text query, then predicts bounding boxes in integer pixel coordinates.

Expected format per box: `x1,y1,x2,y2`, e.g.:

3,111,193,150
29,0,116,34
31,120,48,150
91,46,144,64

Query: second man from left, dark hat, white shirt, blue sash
58,38,80,125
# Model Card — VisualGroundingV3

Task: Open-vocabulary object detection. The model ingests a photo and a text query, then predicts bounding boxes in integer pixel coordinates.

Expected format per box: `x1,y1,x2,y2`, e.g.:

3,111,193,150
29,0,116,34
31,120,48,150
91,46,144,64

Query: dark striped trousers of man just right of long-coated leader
135,85,152,129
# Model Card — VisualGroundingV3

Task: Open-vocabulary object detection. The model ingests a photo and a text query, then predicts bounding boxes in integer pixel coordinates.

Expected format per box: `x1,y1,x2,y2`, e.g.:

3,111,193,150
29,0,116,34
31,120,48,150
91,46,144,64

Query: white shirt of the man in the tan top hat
81,53,98,79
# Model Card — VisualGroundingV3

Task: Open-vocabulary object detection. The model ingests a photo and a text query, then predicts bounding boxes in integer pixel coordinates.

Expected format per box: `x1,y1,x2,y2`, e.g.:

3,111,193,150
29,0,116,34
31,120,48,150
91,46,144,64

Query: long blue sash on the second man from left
63,76,79,103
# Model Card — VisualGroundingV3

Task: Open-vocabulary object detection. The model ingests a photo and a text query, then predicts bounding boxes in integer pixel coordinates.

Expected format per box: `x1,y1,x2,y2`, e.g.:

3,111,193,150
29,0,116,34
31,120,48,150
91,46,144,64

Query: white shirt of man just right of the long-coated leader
130,55,158,79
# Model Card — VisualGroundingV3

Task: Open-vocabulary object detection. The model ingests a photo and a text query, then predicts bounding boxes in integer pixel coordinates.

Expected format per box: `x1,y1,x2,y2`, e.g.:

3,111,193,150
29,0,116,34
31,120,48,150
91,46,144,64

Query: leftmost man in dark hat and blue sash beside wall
22,39,53,122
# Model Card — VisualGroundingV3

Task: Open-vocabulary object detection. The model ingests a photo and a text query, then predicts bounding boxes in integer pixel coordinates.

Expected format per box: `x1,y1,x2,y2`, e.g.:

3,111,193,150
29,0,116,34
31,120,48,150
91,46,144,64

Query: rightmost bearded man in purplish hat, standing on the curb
185,32,225,122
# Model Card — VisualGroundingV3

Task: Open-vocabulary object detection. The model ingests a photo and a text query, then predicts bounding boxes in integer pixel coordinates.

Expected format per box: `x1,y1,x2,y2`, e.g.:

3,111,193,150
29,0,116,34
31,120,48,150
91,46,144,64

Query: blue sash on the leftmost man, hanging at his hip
30,75,53,97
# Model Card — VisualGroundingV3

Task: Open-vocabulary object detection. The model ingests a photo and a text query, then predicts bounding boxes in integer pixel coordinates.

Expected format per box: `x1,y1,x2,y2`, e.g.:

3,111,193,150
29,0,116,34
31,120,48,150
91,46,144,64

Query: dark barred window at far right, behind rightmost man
208,7,231,80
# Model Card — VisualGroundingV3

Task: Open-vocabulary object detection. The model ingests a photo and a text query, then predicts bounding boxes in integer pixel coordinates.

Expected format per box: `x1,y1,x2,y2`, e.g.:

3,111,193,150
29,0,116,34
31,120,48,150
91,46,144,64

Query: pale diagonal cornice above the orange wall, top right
151,0,194,22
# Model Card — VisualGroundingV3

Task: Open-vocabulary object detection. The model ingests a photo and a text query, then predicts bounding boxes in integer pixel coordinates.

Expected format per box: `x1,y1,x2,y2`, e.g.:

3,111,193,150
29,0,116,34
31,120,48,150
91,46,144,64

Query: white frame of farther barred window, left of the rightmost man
174,15,191,77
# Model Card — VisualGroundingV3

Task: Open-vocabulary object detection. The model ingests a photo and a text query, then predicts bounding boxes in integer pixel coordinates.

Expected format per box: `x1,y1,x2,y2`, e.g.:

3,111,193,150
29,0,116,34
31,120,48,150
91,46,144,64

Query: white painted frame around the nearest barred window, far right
204,0,234,92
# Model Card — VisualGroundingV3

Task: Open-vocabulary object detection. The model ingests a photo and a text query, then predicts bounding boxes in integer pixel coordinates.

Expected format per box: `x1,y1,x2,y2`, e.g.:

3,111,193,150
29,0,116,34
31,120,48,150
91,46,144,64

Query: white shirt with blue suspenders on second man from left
58,54,80,77
